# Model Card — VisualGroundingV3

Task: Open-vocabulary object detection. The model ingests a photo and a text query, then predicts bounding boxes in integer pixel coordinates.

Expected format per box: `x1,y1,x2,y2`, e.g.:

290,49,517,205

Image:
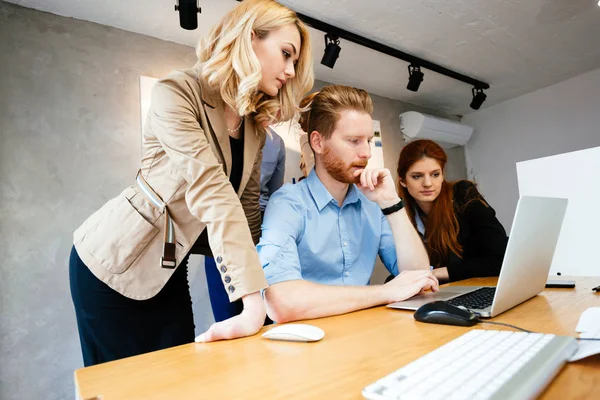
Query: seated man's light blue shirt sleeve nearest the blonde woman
257,186,305,285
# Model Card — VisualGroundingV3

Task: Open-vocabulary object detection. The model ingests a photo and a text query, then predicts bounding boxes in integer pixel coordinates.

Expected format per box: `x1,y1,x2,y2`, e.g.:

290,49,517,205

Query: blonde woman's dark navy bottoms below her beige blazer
69,247,194,367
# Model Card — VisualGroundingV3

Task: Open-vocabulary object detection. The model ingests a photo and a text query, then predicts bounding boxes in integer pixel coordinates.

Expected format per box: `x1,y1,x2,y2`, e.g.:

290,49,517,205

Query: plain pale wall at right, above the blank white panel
462,69,600,230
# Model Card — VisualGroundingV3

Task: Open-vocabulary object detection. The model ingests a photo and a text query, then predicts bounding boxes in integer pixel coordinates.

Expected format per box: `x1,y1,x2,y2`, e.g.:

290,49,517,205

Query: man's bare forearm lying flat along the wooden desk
265,280,388,323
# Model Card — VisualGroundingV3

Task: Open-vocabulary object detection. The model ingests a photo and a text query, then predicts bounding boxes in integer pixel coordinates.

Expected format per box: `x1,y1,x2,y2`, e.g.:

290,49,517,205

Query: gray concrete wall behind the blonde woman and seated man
0,2,466,400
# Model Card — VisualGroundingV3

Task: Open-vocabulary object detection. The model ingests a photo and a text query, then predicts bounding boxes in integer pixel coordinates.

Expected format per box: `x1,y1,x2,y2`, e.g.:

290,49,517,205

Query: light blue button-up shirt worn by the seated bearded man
257,169,398,285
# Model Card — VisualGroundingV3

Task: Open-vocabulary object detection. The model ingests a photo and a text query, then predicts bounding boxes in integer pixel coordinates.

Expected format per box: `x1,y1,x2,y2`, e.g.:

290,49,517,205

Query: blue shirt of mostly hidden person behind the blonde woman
259,128,285,211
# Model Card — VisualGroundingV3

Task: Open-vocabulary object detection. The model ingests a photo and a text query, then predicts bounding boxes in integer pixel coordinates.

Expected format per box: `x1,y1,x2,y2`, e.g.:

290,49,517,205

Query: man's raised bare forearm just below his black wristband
387,209,429,271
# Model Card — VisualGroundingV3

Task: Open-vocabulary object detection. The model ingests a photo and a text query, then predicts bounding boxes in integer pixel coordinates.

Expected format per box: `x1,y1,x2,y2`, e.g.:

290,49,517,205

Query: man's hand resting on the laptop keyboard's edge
383,270,440,303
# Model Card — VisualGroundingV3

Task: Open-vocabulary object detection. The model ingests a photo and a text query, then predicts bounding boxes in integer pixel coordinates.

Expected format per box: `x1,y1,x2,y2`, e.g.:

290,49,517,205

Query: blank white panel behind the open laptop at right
517,147,600,276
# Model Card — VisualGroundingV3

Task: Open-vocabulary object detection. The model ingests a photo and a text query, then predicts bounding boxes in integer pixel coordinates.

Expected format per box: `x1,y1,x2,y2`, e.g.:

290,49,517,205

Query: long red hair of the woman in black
398,140,463,267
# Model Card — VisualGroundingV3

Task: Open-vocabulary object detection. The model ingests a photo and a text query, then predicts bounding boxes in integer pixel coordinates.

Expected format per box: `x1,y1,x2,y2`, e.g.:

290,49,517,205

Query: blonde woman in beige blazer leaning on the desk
69,0,313,366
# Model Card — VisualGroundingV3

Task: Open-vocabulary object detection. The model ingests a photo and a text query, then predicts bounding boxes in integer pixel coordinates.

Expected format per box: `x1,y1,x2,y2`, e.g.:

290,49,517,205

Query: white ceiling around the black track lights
8,0,600,115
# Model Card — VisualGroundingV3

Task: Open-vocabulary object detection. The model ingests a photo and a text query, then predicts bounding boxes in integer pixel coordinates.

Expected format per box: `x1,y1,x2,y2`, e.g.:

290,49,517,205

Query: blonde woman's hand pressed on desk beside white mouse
196,292,267,342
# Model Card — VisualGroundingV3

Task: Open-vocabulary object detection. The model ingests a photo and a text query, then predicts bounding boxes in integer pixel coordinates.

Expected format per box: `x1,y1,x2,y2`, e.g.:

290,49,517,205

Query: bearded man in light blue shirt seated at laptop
257,85,438,323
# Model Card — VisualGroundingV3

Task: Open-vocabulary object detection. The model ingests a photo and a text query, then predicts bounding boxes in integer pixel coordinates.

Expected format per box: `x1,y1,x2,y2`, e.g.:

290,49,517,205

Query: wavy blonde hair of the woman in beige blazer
197,0,314,131
